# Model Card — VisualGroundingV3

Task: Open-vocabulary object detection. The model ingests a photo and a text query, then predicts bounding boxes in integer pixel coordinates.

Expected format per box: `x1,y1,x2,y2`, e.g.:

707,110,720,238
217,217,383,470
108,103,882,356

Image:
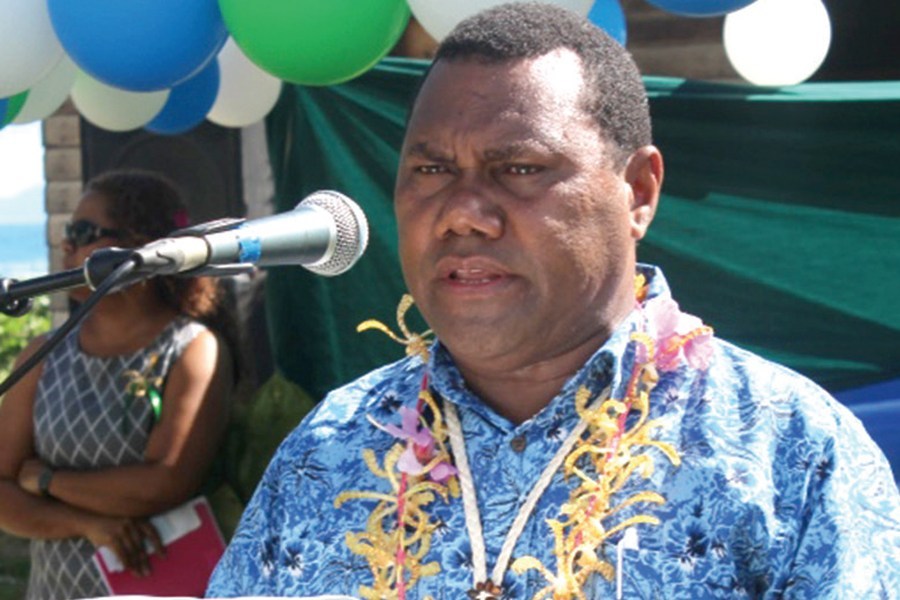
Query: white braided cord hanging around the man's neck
444,387,609,588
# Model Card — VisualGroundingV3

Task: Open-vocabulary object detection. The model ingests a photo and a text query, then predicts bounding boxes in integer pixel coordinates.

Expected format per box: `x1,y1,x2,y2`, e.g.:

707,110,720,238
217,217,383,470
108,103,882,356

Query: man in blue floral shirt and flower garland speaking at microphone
208,4,900,599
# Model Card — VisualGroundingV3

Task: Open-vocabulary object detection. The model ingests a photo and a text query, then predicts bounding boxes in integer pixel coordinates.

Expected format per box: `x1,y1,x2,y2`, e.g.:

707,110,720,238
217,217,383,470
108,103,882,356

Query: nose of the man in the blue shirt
435,172,505,239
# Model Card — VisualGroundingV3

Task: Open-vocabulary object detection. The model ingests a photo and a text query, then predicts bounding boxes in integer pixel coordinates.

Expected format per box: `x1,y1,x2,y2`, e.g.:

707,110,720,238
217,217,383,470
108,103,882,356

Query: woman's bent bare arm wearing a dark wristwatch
19,330,233,517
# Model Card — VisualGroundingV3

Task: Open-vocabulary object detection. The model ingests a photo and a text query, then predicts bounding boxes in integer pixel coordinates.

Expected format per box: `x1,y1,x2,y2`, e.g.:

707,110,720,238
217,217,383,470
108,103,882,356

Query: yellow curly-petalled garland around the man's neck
335,275,711,600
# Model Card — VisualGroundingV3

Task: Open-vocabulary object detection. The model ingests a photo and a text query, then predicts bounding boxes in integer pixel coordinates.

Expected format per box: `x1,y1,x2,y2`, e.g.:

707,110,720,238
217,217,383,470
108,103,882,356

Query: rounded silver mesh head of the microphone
297,190,369,277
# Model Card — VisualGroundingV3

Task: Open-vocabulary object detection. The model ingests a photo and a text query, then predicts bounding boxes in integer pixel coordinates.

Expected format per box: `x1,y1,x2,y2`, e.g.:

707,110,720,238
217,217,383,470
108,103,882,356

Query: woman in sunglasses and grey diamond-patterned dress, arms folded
0,171,234,600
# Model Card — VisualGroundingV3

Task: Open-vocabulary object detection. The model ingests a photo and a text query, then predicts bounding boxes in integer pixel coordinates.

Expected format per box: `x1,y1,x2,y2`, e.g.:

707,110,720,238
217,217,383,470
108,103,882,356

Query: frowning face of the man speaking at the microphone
395,50,655,369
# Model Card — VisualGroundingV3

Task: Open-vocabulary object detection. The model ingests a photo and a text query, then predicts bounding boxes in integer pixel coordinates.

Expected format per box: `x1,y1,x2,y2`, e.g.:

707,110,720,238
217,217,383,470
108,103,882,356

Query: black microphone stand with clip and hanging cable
0,218,255,397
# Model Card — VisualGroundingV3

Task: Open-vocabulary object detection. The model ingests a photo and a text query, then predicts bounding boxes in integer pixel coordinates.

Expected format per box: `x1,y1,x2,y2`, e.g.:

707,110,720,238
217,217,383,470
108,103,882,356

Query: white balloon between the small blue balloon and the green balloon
206,38,282,127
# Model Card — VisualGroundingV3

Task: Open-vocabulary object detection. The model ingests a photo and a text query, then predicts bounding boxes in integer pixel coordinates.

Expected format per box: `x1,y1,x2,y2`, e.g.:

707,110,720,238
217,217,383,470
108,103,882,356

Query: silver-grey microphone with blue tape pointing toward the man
126,190,369,282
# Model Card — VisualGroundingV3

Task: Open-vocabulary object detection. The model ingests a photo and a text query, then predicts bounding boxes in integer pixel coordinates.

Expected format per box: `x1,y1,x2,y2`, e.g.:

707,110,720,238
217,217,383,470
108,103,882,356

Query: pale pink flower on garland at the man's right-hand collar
637,297,713,371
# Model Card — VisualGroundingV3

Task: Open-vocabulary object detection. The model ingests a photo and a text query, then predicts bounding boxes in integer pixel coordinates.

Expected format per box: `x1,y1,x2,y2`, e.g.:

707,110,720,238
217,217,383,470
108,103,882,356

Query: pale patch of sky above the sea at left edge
0,122,46,225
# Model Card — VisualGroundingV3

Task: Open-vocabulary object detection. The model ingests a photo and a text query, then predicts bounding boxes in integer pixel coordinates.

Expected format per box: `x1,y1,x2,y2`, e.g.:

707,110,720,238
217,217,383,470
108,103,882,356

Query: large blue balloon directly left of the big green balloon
47,0,228,92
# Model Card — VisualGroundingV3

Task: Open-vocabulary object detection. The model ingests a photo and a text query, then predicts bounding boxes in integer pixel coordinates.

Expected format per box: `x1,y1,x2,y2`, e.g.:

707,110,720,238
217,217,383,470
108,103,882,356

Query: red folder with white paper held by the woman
94,497,225,598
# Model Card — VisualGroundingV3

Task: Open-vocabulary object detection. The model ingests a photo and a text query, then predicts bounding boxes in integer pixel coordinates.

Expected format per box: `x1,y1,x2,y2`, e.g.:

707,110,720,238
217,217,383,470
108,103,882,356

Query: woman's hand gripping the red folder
84,516,165,576
